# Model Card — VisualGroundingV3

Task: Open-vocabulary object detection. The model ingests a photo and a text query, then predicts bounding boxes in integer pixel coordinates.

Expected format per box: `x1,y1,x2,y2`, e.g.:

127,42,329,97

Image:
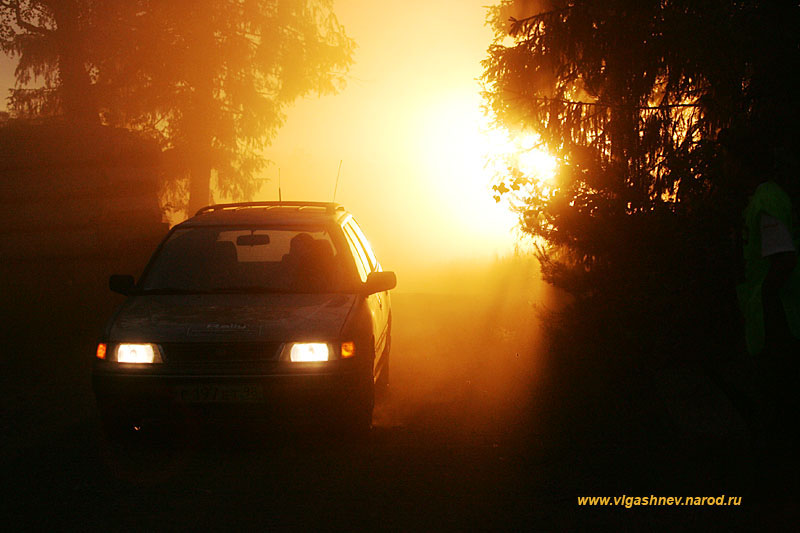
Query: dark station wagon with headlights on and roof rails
92,201,397,436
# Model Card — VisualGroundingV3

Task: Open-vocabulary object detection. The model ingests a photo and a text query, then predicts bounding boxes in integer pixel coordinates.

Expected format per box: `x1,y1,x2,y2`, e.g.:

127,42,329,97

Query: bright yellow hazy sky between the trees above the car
0,0,514,280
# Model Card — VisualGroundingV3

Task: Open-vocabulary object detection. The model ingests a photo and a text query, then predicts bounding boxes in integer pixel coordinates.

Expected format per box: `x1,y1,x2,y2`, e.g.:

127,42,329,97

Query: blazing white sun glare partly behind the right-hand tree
420,94,556,252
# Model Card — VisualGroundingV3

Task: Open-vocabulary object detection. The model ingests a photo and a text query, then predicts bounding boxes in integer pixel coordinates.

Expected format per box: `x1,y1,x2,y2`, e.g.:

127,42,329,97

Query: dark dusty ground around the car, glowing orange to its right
2,260,797,531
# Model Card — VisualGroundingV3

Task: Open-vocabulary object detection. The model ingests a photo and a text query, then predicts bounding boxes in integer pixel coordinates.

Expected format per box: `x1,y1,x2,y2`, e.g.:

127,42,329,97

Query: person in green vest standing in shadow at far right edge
737,181,800,440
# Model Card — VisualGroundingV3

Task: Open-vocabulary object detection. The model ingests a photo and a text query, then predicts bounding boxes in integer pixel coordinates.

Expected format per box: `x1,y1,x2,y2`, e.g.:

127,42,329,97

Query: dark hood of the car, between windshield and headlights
108,294,355,342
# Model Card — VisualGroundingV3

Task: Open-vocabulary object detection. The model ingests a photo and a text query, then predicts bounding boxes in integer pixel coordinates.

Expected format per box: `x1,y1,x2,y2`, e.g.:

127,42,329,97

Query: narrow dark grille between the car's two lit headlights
161,342,281,364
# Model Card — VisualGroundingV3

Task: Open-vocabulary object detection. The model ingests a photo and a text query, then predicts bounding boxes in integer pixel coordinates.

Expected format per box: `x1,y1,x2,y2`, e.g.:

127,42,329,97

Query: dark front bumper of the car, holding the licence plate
92,361,372,419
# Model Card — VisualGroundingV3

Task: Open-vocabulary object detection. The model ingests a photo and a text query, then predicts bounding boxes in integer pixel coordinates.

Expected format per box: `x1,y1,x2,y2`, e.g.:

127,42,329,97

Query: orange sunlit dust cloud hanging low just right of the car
374,256,558,436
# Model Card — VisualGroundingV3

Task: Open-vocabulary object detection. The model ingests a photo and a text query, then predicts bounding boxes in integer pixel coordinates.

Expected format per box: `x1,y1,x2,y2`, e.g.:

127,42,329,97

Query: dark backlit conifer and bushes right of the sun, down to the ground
483,0,800,358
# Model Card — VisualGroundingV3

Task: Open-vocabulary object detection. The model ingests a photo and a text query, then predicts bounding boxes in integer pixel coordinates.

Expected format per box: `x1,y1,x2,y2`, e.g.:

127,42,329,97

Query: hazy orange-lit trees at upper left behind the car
1,0,354,212
